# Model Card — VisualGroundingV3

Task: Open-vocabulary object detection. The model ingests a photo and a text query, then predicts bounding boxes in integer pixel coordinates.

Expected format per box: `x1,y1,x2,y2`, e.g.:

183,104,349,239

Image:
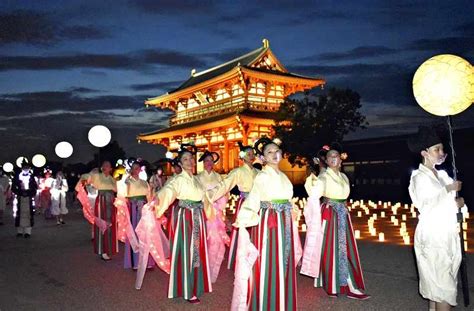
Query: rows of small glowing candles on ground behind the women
226,195,470,250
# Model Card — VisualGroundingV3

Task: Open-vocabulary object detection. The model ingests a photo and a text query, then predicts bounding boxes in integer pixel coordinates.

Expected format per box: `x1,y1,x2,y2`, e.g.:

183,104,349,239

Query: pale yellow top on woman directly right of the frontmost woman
308,168,351,200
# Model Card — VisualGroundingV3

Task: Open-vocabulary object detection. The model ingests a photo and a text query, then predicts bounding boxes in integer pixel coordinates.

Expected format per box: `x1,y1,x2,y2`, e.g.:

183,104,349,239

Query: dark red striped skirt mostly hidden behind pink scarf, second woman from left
123,196,155,269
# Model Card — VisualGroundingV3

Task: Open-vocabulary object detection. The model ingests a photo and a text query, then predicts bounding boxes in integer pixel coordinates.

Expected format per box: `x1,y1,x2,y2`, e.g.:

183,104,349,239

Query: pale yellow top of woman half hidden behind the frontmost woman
211,164,259,202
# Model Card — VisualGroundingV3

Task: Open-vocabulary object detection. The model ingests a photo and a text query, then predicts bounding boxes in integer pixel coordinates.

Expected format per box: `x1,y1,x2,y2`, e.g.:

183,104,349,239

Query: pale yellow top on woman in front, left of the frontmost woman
155,171,204,218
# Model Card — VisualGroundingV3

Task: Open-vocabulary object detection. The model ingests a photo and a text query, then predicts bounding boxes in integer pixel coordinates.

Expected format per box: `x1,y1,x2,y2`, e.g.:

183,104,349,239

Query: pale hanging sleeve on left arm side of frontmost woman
234,174,265,228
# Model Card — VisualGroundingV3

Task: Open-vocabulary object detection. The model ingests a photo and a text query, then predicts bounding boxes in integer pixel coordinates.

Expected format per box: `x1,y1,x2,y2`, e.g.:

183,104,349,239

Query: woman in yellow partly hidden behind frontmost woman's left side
208,142,259,269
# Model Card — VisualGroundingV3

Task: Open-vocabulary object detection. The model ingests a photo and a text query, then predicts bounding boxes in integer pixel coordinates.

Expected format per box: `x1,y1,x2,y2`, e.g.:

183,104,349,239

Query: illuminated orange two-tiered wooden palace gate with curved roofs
138,39,325,179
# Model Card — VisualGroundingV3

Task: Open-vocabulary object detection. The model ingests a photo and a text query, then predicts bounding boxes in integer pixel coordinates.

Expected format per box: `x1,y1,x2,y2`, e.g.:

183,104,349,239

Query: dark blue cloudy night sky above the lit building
0,0,474,164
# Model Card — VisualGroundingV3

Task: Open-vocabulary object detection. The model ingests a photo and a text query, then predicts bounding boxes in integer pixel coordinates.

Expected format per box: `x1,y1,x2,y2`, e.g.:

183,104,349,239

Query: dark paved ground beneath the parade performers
0,210,474,311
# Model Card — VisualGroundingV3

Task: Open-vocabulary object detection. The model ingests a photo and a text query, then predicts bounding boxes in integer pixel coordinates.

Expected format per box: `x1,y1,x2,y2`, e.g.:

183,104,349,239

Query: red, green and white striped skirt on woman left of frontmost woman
168,201,212,299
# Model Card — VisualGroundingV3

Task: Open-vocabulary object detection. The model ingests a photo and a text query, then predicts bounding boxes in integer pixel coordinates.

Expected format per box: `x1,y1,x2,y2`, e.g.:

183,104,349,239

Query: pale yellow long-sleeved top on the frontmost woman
234,166,293,227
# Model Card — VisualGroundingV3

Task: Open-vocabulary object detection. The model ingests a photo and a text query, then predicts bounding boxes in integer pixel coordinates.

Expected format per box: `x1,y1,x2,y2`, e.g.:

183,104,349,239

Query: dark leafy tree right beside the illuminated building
273,88,368,165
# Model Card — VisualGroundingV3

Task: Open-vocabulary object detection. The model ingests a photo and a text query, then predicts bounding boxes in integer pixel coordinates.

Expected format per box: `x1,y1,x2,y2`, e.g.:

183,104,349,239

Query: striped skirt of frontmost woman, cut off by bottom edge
248,208,297,310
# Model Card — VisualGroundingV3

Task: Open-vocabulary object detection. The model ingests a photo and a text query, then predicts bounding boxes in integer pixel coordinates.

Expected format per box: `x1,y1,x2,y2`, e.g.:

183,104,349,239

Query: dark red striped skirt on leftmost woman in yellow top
93,190,118,256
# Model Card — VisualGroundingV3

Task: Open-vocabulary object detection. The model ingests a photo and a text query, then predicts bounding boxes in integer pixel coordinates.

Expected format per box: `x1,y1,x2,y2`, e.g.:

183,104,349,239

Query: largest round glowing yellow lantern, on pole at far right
413,54,474,116
